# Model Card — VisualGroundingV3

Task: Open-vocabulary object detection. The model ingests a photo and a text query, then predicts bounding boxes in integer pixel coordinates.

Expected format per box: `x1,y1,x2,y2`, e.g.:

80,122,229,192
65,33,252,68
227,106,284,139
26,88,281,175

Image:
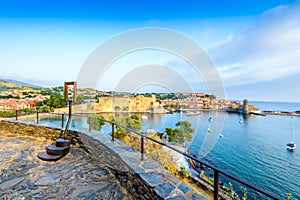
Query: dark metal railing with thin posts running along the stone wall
9,111,282,200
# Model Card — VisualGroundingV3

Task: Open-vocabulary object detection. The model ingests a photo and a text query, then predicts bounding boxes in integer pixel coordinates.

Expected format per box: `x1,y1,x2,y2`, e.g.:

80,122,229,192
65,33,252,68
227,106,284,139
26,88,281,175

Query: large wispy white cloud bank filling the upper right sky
209,2,300,86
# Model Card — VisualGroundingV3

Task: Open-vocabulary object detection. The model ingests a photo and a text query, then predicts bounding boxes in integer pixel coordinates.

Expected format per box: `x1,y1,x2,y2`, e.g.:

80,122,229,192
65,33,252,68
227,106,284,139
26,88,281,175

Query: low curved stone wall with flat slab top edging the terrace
0,120,206,200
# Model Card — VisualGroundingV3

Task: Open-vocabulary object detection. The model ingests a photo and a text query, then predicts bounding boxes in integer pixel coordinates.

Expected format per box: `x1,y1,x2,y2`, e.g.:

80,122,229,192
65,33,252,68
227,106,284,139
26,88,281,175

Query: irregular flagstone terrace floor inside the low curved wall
0,133,130,200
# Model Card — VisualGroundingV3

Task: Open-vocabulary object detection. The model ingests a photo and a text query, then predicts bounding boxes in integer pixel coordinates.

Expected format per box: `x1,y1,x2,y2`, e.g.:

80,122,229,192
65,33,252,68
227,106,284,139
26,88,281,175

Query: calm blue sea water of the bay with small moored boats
33,101,300,199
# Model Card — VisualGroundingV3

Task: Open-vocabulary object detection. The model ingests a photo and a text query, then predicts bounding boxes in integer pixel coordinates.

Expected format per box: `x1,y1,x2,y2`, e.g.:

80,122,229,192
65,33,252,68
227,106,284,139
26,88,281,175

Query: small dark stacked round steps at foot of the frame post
37,138,71,161
